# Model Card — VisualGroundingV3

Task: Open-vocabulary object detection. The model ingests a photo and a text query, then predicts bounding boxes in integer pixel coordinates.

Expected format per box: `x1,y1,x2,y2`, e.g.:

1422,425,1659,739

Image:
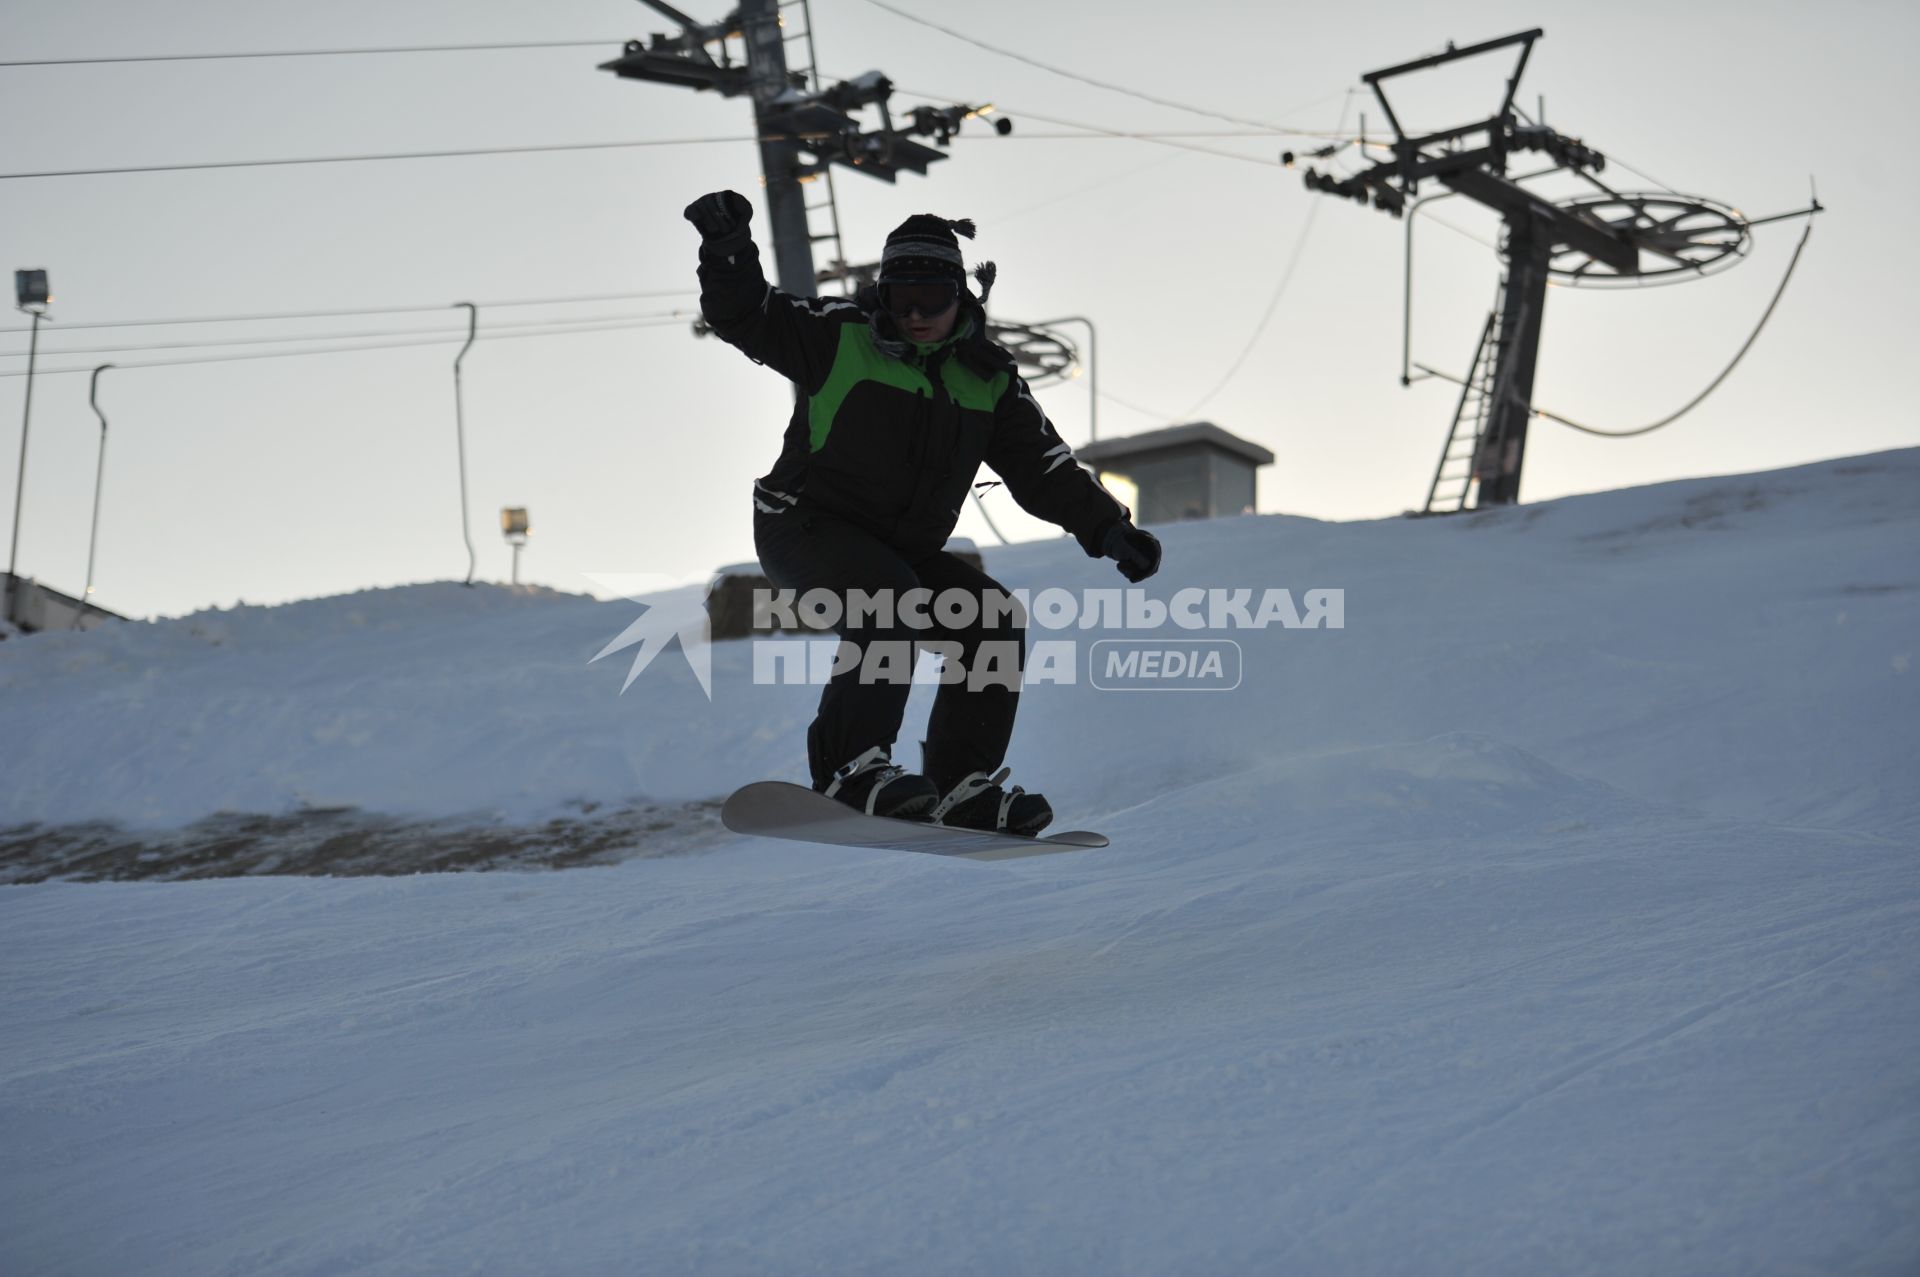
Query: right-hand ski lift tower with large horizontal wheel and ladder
1284,29,1820,513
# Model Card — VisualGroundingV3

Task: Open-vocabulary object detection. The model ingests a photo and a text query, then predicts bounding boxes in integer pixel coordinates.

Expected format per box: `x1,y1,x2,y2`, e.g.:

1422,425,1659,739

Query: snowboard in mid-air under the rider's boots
720,780,1106,860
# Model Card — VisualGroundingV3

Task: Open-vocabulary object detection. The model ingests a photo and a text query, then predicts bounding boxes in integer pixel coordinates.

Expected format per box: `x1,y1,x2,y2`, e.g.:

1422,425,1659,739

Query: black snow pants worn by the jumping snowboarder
753,509,1025,793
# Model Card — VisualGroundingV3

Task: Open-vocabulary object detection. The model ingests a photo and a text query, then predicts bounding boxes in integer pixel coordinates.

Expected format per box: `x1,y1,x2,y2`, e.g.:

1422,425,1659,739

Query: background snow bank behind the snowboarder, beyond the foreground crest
0,451,1920,828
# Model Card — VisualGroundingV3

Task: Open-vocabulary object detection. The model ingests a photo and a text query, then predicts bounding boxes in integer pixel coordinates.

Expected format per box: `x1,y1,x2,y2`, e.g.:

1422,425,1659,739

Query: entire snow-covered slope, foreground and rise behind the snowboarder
0,451,1920,1273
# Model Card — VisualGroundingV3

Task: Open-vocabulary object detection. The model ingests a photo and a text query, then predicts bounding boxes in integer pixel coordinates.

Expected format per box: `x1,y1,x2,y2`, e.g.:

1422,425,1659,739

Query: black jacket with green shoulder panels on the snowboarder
699,235,1131,563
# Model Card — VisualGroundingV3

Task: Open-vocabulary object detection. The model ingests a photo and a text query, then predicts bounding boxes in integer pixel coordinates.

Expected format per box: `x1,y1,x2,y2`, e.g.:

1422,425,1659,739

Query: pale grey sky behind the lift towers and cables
0,0,1920,616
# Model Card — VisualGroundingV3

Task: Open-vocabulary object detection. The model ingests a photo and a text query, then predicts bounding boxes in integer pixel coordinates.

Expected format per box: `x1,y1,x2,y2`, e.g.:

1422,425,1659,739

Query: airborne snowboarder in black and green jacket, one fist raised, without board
685,190,1160,835
